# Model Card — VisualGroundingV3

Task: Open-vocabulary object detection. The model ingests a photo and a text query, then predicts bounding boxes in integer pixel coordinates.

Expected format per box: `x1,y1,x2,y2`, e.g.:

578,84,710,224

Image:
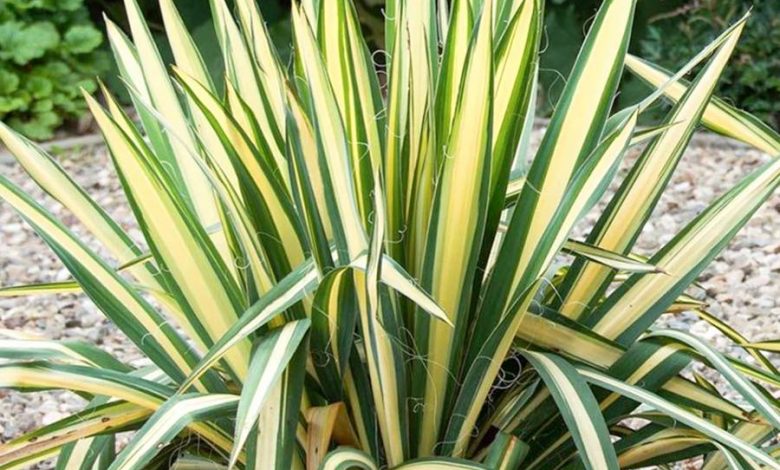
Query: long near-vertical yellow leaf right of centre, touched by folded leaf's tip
412,0,494,455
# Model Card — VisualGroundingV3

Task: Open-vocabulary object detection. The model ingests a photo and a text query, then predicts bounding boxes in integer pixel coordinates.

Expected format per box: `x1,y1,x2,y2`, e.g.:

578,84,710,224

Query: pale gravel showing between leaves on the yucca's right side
616,136,780,392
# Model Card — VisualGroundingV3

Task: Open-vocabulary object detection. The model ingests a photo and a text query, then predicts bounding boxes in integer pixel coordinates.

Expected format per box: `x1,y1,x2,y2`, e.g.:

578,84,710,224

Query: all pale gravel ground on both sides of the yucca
0,131,780,462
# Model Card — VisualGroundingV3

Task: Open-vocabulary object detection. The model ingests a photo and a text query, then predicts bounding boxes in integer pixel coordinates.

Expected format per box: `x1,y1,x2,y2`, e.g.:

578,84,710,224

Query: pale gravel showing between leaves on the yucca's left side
0,145,142,442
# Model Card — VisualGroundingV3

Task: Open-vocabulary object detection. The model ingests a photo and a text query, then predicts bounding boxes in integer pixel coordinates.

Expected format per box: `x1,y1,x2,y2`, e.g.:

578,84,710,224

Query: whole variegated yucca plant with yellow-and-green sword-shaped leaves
0,0,780,470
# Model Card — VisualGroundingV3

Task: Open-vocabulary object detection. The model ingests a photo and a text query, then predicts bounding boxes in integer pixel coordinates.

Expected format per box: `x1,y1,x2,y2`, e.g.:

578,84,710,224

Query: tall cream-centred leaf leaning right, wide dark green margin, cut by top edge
474,0,635,350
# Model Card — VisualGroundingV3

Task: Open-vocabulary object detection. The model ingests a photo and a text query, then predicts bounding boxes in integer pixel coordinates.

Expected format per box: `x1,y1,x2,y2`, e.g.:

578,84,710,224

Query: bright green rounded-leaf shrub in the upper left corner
0,0,109,139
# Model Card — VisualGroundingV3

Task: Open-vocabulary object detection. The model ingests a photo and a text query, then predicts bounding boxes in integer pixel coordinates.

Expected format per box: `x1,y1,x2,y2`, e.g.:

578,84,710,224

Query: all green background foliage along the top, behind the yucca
6,0,780,140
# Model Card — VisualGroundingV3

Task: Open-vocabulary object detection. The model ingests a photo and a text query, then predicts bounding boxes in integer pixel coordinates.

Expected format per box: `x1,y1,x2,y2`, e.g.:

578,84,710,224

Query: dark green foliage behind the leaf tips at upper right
539,0,780,129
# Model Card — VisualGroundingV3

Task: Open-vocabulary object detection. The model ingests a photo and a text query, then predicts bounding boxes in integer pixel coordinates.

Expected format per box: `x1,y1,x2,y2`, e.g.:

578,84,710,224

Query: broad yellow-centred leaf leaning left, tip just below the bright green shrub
87,92,249,379
